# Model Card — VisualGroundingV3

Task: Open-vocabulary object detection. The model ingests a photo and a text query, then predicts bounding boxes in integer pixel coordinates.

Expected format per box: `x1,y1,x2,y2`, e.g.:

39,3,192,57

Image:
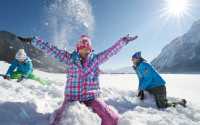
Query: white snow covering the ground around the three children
0,62,200,125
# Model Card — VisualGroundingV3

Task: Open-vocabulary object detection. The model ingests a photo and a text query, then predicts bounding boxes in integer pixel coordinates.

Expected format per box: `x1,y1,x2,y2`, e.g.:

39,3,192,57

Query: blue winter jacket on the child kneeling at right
136,61,166,90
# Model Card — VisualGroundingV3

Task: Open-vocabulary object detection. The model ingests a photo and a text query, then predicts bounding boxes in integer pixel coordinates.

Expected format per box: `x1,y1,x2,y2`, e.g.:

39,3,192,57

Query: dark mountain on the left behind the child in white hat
0,31,65,72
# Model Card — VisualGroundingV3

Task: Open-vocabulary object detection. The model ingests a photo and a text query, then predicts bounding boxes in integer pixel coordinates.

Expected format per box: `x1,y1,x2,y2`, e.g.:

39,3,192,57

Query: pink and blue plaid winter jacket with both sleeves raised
32,37,128,101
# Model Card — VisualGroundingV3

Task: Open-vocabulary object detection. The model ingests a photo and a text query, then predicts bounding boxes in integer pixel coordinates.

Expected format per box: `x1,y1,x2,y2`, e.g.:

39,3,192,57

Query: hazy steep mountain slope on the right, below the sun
152,20,200,73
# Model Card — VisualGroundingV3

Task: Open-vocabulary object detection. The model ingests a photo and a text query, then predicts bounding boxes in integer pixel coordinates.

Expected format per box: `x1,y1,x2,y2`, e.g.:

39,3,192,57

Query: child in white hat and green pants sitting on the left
4,49,44,84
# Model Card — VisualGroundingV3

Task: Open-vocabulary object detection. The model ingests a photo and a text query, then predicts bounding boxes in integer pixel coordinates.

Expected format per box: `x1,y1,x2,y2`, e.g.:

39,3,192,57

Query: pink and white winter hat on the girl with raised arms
76,35,92,52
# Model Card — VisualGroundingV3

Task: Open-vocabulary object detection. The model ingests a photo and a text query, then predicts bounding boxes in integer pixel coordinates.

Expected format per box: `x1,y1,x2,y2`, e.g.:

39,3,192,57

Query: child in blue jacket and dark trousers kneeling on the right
132,52,186,108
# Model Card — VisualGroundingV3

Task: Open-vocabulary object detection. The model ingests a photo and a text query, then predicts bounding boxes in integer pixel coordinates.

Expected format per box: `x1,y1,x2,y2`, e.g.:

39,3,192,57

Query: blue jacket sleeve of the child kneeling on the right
139,63,153,90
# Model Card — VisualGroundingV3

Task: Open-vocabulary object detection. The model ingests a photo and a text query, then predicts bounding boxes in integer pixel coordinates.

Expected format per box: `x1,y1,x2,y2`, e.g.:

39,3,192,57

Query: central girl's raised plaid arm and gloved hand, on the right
97,35,138,64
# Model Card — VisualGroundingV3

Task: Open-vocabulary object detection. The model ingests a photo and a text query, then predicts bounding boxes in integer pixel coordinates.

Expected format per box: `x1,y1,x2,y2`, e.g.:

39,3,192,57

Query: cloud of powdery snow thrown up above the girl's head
42,0,95,49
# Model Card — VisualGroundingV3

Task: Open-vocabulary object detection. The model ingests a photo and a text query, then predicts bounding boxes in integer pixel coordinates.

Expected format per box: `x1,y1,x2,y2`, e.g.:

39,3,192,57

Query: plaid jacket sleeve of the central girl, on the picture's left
32,37,71,64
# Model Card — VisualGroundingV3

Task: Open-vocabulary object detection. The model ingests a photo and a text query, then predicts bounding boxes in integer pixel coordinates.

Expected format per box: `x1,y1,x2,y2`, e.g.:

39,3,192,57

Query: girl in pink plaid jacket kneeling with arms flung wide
18,35,137,125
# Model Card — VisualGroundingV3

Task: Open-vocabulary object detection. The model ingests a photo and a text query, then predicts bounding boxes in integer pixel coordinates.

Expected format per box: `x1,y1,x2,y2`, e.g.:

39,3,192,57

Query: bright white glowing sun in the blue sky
164,0,191,17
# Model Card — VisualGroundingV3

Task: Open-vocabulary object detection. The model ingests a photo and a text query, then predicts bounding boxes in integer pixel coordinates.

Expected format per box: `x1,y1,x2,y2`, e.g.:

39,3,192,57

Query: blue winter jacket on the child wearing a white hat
6,57,33,77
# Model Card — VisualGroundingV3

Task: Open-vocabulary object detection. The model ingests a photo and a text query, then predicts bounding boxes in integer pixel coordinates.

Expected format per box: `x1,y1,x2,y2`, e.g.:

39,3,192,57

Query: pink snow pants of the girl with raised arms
51,97,119,125
